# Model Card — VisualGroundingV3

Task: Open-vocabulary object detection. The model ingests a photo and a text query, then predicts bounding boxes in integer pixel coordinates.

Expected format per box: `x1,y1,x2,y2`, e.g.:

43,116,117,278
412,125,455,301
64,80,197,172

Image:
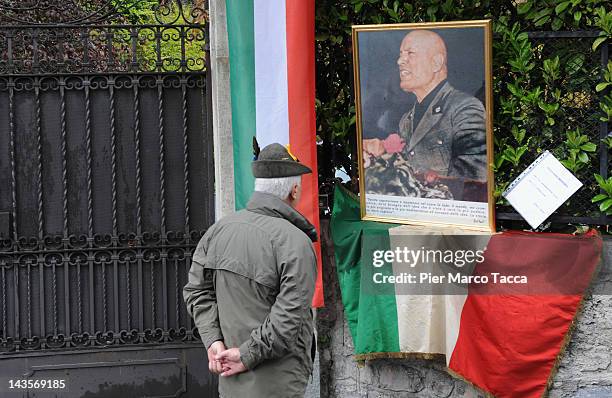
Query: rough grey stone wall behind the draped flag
317,220,612,398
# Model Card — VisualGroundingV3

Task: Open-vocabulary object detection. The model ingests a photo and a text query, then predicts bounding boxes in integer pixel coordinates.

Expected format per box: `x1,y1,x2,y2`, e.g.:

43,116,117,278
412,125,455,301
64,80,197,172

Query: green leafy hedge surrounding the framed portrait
315,0,612,224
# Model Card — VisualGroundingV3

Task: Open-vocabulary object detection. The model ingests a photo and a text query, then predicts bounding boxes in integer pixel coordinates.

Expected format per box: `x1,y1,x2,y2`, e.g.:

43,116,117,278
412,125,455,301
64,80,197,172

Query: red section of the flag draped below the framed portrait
449,231,602,398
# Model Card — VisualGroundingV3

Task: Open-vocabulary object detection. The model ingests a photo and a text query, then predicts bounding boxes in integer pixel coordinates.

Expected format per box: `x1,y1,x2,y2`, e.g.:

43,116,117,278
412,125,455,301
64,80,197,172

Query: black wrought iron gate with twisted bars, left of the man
0,0,216,397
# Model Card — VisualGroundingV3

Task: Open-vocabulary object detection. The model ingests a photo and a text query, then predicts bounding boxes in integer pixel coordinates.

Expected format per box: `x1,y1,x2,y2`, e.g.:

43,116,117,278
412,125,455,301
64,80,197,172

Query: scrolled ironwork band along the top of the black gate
0,0,208,75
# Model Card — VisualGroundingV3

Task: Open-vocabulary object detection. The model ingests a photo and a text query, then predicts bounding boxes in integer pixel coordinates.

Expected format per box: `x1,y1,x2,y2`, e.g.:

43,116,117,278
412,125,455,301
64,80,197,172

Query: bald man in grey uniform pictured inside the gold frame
363,30,487,181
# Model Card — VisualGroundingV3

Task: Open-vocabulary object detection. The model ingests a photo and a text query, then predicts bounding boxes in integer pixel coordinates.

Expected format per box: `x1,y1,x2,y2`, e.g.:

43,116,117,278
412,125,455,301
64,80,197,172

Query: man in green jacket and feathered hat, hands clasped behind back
183,144,317,398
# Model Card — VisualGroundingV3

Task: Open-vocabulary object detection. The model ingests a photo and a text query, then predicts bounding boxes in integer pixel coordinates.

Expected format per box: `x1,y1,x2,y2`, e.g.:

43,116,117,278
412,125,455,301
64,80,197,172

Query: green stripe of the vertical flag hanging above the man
226,0,255,210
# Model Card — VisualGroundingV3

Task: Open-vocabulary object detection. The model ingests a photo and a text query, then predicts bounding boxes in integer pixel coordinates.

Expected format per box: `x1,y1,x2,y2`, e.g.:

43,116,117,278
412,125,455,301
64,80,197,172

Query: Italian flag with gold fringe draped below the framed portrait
331,188,603,398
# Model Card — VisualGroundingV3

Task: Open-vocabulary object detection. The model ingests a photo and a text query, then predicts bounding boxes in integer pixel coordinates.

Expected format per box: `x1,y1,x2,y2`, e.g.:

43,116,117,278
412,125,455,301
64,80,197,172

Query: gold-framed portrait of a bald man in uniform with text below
352,20,495,231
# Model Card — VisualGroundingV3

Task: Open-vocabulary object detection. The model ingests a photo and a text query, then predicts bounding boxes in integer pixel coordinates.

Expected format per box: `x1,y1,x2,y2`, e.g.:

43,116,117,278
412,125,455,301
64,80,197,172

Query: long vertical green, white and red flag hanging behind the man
226,0,323,307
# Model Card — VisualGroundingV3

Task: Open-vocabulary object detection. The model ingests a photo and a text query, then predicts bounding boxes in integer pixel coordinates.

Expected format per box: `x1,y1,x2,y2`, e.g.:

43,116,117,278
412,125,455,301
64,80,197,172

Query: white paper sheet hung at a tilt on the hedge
503,151,582,229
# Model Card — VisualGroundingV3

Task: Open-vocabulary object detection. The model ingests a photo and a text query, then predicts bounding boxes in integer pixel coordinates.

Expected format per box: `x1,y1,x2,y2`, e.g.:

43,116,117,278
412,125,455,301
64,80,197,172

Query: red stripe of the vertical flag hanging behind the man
286,0,323,307
